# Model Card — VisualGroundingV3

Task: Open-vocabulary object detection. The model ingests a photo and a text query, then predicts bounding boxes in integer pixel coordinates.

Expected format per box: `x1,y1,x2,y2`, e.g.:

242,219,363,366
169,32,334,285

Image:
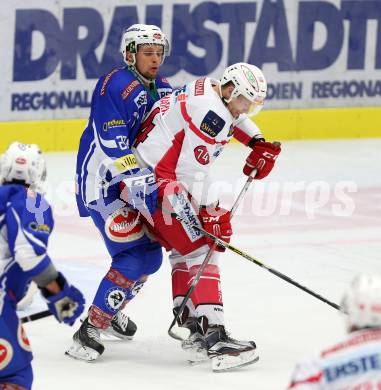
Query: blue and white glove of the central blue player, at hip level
119,168,158,215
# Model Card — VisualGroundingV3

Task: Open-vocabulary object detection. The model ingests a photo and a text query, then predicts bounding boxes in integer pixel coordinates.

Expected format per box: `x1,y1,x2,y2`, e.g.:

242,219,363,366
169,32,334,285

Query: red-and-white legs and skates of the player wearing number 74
147,184,257,369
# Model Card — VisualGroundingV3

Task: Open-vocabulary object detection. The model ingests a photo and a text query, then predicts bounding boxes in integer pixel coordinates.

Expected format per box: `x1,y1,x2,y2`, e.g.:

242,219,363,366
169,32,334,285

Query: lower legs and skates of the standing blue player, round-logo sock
67,243,162,361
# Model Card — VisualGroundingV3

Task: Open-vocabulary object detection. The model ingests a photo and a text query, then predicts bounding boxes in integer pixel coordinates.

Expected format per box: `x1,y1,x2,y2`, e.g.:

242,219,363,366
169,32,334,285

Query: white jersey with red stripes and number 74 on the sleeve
134,77,262,204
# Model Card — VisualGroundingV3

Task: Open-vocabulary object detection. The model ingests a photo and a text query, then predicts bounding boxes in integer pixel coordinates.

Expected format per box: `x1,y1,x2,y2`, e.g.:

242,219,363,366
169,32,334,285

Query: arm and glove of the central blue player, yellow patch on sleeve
94,78,157,214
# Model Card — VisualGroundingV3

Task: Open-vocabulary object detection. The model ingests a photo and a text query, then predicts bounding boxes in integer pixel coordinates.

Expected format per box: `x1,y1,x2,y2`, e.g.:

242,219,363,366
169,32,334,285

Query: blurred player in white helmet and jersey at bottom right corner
288,274,381,390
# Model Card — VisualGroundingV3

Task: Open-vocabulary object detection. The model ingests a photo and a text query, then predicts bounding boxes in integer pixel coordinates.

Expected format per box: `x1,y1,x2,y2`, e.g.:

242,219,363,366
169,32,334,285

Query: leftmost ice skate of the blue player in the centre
65,318,105,362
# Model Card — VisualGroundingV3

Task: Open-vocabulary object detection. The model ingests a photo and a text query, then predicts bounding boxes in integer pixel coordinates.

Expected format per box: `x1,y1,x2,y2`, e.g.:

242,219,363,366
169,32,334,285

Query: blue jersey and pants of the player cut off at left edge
0,185,53,389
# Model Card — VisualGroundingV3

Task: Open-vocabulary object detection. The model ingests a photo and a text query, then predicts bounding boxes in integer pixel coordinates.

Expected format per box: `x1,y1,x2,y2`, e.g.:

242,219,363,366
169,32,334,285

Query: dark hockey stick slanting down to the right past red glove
168,203,342,324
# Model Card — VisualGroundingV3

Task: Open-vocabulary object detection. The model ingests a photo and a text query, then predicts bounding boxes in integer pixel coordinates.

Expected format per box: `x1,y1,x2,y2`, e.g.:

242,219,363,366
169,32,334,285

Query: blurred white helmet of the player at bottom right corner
341,274,381,332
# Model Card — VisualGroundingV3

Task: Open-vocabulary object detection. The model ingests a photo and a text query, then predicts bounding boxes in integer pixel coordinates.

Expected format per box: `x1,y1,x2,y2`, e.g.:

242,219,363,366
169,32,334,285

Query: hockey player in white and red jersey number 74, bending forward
134,63,280,370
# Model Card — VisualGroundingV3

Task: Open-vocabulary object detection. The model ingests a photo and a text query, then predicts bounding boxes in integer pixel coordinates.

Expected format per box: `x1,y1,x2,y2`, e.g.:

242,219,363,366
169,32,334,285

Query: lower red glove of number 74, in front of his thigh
200,207,233,252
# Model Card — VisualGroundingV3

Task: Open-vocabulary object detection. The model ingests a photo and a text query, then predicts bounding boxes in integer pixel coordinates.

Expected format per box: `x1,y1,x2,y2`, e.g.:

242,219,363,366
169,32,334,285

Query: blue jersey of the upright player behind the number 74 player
76,67,172,216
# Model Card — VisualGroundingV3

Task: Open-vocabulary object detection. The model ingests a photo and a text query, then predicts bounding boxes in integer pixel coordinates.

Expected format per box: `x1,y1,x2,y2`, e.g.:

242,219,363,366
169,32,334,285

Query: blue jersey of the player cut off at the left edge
0,185,54,306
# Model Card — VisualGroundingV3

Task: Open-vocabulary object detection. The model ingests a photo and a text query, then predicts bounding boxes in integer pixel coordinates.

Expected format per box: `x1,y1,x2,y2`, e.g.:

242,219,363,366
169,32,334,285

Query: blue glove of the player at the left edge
40,272,85,326
